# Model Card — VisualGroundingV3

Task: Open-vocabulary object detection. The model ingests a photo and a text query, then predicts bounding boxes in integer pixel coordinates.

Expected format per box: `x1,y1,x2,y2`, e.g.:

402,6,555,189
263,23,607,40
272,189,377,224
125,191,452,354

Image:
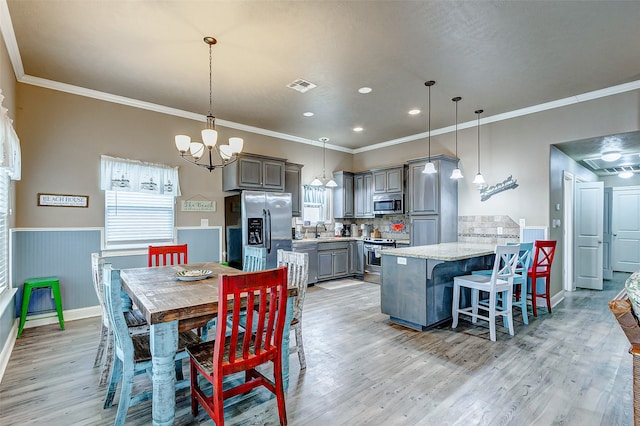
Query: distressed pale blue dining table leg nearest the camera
150,321,178,426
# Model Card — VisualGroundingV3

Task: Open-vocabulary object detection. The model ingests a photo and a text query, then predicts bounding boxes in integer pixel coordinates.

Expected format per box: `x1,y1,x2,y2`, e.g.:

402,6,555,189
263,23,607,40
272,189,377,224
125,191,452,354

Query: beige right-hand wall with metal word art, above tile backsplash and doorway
354,91,640,225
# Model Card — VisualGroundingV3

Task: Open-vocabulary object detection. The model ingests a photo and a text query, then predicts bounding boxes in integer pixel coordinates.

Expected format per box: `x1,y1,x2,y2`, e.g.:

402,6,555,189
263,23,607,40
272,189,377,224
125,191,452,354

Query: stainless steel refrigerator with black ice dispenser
224,191,291,268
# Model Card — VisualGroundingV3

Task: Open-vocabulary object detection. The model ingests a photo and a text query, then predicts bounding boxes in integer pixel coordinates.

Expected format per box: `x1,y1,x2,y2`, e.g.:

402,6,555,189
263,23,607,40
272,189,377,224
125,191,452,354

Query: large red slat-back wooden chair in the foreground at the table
187,267,287,426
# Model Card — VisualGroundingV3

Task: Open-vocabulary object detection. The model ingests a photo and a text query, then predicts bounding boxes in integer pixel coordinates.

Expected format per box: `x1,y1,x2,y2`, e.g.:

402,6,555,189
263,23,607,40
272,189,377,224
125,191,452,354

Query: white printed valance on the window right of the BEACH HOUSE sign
100,155,180,197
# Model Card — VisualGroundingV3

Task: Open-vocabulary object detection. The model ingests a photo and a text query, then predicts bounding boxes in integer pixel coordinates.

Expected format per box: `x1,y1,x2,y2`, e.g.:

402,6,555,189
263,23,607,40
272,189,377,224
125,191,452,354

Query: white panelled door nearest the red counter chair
574,182,604,290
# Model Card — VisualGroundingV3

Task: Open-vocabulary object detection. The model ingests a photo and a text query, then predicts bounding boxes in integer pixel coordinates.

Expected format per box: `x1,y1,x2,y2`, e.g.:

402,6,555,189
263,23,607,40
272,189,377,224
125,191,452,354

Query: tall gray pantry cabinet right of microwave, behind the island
407,155,458,246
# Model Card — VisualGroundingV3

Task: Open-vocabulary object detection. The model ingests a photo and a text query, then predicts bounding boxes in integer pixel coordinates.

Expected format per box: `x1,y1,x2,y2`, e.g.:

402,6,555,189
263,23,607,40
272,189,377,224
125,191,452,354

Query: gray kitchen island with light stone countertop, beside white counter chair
380,242,495,331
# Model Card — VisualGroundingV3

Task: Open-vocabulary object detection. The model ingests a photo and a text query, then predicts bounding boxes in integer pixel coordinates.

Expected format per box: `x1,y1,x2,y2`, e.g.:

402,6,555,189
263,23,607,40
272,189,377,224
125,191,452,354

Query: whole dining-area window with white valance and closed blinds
100,155,180,249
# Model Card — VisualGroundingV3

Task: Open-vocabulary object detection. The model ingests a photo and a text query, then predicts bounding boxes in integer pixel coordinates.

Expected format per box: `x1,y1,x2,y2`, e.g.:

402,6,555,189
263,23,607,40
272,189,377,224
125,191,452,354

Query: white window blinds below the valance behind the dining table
104,190,175,248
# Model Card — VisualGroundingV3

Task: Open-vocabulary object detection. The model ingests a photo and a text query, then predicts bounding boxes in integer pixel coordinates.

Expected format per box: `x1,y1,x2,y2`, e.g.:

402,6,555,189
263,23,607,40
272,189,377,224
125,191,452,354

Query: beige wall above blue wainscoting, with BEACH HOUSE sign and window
16,84,352,227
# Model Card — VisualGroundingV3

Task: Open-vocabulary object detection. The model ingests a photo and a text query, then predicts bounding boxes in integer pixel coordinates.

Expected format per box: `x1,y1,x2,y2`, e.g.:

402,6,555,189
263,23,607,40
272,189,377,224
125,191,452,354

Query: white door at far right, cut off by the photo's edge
612,186,640,272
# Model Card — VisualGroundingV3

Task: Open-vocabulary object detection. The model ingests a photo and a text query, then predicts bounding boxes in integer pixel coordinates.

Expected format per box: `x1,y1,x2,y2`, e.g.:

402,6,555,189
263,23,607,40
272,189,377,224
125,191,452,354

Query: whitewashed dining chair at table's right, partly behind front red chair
278,250,309,370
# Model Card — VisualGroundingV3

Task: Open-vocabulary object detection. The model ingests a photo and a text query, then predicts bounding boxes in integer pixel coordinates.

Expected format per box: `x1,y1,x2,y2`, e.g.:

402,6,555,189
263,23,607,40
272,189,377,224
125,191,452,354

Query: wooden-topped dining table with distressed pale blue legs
120,262,297,425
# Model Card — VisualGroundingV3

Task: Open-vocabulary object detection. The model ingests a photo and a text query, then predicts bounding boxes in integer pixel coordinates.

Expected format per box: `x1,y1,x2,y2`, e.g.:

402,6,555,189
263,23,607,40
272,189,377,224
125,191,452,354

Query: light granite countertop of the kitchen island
378,242,496,261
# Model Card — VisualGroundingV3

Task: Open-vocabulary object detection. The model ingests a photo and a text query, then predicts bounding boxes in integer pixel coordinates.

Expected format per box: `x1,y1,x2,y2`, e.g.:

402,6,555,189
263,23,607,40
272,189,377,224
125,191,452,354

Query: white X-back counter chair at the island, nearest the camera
451,245,520,342
